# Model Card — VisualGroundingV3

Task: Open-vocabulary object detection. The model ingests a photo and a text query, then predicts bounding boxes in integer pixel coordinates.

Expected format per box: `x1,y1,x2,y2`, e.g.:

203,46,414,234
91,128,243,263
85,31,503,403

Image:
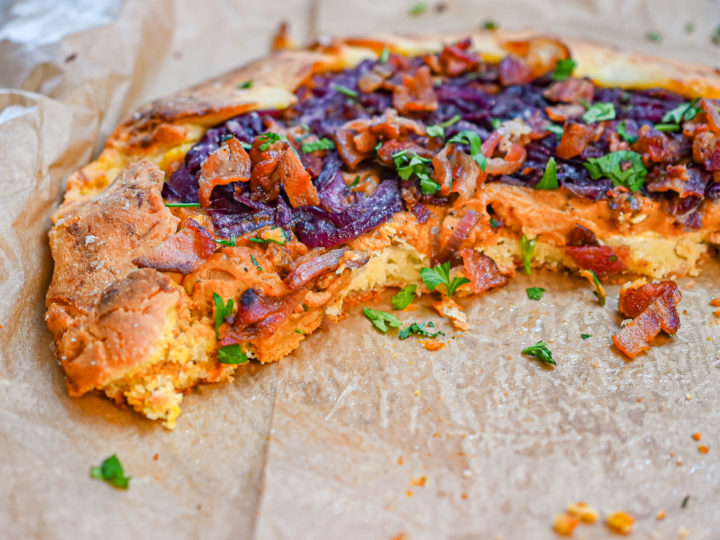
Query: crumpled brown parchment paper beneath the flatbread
0,0,720,539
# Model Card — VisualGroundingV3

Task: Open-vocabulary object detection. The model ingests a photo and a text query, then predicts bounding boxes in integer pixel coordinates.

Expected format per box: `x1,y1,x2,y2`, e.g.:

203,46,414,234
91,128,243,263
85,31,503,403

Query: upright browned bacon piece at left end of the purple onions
198,137,250,208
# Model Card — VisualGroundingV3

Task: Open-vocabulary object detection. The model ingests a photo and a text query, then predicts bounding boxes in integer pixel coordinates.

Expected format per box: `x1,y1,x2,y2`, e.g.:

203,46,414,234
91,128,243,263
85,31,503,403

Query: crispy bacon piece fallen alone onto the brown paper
612,281,682,358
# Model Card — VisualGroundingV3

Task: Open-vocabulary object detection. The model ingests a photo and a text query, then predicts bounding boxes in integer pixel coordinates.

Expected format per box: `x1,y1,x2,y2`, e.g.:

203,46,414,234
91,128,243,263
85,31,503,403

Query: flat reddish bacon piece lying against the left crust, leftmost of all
133,219,216,274
